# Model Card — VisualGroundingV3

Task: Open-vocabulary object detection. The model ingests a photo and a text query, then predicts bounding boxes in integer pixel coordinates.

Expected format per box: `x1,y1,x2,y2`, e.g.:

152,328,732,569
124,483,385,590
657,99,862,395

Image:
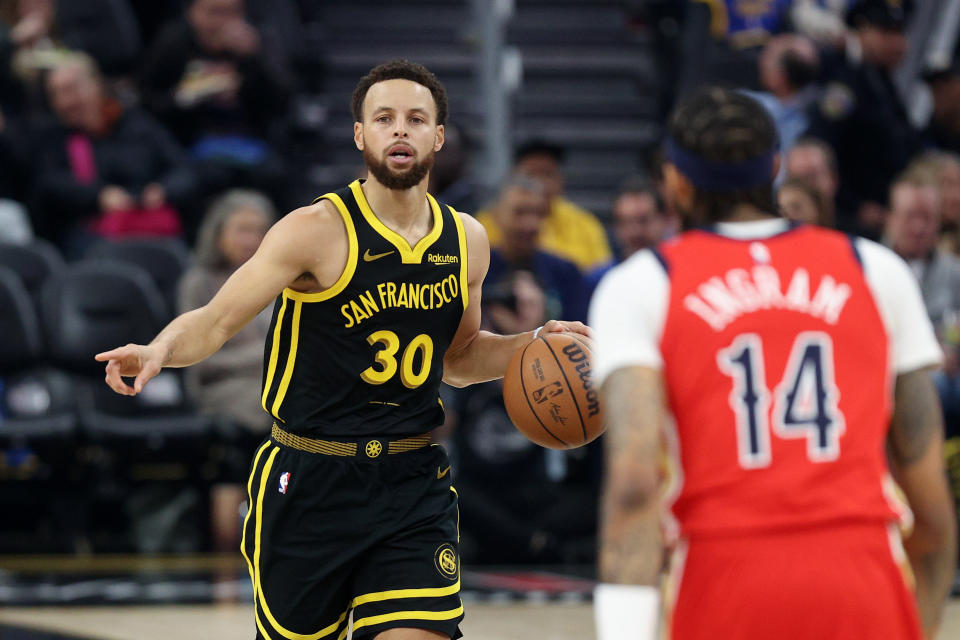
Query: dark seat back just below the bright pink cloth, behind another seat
86,238,190,317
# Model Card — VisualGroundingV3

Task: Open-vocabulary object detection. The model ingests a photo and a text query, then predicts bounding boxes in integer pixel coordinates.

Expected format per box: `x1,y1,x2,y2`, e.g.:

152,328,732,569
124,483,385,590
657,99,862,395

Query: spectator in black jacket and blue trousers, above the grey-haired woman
140,0,292,205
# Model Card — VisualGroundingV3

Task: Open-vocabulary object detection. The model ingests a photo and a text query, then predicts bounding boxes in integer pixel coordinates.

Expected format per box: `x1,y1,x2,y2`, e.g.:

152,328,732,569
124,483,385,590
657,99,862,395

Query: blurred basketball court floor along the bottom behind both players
0,554,960,640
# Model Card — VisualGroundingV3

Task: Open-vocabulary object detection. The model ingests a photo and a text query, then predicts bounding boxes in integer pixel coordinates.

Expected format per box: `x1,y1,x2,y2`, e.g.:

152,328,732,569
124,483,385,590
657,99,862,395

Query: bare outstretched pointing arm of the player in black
95,201,346,395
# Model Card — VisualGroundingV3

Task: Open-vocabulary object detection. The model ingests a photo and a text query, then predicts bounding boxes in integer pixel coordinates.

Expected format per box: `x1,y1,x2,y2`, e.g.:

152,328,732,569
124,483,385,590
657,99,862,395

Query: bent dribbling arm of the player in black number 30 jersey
443,214,590,387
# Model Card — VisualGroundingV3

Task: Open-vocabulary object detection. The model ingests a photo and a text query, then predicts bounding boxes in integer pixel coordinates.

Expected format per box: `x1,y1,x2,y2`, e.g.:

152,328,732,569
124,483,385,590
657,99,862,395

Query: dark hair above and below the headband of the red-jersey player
669,87,778,223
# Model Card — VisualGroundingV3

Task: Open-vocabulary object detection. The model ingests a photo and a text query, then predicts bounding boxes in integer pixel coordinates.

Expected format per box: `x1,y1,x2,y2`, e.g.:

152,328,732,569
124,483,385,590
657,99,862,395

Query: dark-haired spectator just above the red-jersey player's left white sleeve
586,176,676,293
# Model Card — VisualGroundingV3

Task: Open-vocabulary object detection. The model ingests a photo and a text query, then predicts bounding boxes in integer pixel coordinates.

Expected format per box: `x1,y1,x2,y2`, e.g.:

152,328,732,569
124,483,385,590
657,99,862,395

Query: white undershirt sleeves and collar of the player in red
590,219,943,385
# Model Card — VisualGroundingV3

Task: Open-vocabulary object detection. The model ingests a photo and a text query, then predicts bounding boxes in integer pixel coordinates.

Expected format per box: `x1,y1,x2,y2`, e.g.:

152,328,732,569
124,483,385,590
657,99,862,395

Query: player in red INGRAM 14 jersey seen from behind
590,89,956,640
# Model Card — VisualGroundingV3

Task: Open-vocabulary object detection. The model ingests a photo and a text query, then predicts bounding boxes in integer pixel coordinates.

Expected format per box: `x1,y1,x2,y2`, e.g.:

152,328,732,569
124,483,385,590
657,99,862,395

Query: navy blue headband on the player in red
663,137,777,192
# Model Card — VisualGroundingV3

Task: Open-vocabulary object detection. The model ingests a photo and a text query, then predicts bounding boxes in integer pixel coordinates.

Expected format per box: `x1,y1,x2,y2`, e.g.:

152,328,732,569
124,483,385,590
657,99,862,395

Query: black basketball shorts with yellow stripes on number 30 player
241,430,463,640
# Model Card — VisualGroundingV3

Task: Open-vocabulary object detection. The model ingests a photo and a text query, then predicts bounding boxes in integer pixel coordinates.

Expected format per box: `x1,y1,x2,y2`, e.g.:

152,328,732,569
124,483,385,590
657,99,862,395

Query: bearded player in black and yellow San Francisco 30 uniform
97,61,589,640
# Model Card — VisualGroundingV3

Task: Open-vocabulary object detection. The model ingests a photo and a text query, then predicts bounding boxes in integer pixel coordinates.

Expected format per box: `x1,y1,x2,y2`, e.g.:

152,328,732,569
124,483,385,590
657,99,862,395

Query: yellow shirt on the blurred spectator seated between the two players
477,197,613,273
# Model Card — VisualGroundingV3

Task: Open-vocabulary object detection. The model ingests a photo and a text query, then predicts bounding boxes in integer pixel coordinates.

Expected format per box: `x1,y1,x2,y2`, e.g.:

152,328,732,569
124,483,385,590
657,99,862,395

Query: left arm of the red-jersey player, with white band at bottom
594,366,665,640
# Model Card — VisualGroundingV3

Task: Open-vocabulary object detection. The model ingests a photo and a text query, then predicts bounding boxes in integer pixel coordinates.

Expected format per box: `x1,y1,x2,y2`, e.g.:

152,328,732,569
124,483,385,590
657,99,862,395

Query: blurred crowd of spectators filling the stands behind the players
0,0,960,563
